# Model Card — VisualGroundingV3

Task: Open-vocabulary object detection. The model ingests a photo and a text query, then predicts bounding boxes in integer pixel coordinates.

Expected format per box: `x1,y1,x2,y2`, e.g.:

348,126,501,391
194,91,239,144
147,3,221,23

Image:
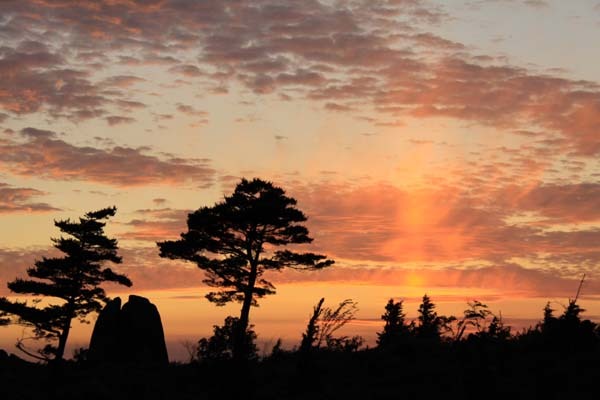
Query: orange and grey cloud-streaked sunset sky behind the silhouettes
0,0,600,360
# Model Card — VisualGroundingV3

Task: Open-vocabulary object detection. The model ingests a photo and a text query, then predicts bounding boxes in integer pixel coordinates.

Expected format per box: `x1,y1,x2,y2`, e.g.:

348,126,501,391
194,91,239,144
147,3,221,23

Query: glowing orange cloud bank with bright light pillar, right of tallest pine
280,184,600,272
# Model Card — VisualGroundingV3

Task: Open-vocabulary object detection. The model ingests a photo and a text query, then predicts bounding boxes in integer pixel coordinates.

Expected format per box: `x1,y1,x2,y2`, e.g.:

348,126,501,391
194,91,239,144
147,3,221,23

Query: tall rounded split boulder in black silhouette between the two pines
88,295,169,365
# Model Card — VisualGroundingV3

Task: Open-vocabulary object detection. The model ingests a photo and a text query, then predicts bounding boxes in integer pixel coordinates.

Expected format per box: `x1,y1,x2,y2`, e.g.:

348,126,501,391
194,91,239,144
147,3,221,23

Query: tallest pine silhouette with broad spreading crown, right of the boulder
157,179,333,359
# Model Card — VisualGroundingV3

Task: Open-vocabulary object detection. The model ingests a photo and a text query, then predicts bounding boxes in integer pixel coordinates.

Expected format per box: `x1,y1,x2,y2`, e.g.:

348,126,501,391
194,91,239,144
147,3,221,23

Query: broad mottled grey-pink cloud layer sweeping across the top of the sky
0,0,600,156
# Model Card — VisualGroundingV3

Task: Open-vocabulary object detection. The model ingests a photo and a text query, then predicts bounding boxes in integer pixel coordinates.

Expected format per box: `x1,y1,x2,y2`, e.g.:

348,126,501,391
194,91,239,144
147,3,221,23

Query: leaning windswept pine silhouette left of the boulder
0,207,131,360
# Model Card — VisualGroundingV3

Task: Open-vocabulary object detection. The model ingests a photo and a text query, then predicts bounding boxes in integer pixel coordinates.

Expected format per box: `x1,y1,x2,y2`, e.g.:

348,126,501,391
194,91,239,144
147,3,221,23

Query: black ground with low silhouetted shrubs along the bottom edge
0,290,600,399
